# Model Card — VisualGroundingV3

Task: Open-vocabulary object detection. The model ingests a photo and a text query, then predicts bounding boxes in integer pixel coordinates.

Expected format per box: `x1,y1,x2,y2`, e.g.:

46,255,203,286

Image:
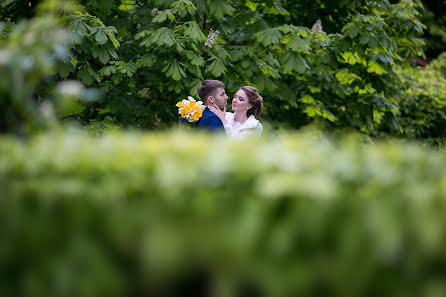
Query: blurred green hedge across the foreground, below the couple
0,132,446,297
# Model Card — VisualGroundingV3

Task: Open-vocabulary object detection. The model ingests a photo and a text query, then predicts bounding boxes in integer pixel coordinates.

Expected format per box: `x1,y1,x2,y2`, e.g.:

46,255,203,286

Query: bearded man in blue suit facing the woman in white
181,79,228,131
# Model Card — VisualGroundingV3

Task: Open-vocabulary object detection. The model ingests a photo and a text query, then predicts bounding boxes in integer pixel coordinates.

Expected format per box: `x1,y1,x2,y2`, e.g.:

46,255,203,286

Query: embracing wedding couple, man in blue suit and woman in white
183,80,263,139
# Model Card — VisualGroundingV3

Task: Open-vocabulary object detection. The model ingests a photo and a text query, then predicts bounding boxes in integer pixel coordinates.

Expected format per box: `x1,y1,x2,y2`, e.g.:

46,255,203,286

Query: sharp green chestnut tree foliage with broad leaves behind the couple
0,0,423,134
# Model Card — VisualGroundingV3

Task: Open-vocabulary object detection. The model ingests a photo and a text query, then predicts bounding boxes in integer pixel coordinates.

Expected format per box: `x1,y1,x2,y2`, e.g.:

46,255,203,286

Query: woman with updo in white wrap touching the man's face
209,86,263,139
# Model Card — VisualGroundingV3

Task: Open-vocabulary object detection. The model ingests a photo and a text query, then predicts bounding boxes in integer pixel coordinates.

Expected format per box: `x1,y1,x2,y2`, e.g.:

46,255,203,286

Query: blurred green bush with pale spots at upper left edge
0,1,100,135
